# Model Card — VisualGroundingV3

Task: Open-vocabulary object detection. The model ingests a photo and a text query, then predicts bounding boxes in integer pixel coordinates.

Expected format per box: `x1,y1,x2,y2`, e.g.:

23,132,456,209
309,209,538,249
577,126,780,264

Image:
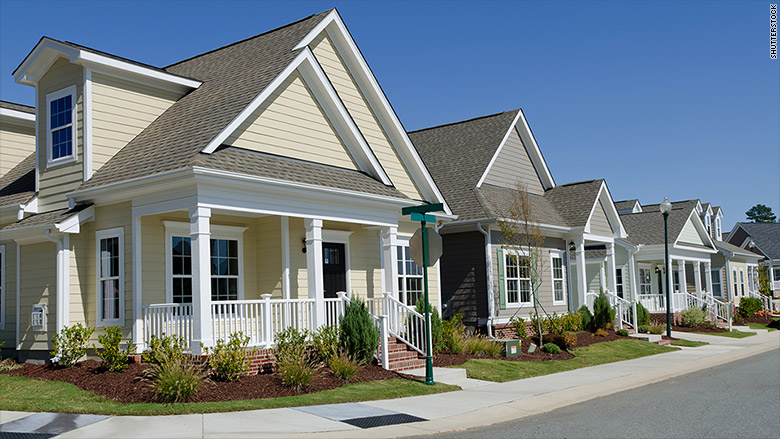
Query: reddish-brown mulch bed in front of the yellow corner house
4,360,408,403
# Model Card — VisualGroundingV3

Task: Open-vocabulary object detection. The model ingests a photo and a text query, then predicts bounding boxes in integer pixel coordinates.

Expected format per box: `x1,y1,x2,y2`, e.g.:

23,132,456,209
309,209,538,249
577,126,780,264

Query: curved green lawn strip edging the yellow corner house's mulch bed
0,375,460,415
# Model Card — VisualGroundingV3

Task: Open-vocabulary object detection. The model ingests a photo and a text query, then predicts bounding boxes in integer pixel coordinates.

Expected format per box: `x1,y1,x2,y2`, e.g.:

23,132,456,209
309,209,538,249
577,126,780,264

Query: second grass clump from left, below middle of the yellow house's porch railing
274,327,317,391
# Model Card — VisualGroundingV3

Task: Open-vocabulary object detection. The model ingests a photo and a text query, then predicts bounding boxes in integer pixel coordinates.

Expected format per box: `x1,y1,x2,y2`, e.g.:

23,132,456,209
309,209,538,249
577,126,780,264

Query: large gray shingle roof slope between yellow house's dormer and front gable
79,11,330,189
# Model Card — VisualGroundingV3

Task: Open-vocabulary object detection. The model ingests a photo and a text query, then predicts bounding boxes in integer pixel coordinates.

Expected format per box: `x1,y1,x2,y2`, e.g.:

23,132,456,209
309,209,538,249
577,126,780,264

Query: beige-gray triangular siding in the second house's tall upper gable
485,128,544,195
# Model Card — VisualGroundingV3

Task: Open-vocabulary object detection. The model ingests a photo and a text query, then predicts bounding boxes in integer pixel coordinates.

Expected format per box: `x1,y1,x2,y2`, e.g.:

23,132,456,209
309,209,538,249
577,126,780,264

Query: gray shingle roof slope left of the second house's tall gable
409,110,520,221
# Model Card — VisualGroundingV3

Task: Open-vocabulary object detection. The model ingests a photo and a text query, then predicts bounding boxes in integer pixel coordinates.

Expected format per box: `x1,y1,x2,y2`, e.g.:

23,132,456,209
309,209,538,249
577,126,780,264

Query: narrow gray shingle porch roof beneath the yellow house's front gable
200,147,408,198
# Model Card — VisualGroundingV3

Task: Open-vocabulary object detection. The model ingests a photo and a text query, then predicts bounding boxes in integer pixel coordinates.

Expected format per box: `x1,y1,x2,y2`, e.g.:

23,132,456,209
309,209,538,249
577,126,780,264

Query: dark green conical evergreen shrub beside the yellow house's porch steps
339,298,379,363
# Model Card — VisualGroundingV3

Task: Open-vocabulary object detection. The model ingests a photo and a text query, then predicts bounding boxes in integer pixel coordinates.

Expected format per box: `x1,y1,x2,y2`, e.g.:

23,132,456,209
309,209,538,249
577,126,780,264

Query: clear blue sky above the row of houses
0,0,780,230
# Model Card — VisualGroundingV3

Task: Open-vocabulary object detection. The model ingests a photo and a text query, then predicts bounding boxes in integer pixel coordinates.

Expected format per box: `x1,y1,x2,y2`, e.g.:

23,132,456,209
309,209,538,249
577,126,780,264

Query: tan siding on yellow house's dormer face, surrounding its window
37,58,84,211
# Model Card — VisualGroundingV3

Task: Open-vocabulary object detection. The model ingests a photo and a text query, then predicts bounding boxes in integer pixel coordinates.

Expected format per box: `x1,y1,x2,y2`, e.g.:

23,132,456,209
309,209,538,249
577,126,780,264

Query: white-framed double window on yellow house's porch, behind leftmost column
163,221,246,303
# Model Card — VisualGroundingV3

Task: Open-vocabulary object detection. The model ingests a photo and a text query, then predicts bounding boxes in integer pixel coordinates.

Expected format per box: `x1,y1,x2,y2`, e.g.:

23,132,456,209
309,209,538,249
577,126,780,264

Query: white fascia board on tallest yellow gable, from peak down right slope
302,10,452,215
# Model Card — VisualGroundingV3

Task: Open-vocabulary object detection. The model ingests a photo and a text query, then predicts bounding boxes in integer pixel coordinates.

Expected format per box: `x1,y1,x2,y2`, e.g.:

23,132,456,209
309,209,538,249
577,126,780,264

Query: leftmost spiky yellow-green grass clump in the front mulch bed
144,352,206,402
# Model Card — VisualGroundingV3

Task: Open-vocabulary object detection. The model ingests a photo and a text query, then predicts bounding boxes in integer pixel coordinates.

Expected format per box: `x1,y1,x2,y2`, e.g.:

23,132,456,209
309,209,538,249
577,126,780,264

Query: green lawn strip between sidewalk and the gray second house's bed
453,340,679,383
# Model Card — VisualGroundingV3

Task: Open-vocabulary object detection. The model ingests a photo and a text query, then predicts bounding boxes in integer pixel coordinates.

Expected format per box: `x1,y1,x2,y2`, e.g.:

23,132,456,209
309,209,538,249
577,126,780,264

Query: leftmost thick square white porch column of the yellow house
190,207,214,355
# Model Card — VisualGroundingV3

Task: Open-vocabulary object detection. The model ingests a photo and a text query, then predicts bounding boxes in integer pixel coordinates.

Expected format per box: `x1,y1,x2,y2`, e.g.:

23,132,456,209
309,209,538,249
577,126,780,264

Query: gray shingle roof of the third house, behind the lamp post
620,200,710,248
